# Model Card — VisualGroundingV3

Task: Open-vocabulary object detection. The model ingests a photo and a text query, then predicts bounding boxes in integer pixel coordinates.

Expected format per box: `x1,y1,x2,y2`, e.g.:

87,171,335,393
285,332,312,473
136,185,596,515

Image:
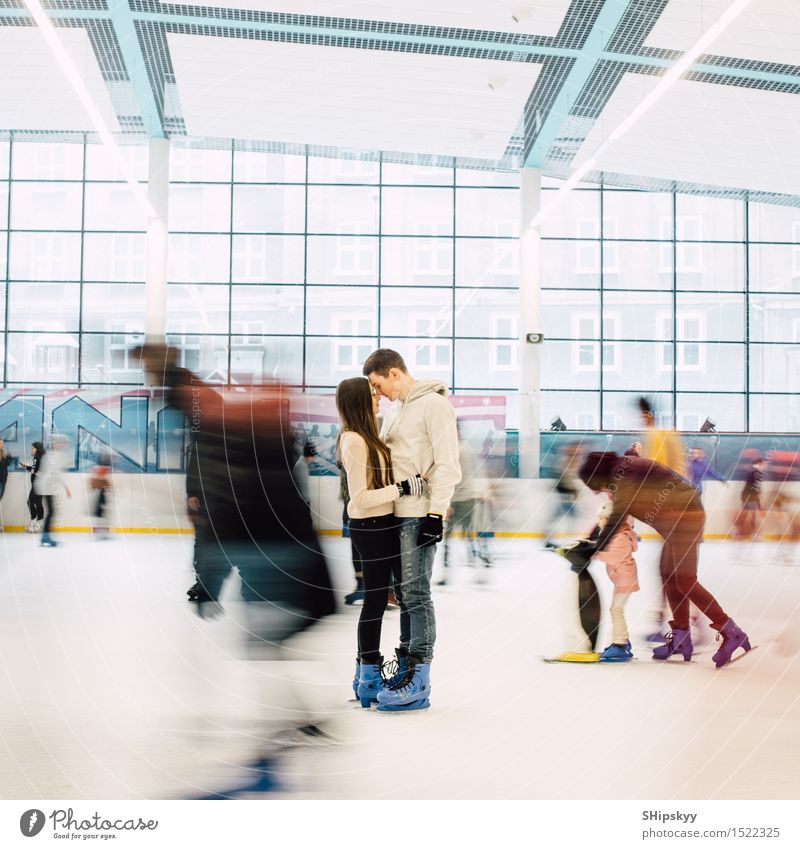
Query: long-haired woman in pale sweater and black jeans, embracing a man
336,377,424,708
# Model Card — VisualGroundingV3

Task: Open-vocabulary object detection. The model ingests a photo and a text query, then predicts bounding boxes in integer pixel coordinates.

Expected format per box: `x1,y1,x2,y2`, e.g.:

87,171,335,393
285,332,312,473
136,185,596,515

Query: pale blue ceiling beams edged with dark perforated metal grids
0,0,800,202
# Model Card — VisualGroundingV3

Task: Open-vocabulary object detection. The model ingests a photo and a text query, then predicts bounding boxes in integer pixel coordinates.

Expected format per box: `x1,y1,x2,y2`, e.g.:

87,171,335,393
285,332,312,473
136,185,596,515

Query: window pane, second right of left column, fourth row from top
231,286,303,337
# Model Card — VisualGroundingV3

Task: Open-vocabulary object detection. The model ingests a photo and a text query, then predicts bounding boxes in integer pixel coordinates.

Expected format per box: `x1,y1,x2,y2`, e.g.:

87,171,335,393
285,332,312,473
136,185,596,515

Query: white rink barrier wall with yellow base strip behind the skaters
0,472,800,539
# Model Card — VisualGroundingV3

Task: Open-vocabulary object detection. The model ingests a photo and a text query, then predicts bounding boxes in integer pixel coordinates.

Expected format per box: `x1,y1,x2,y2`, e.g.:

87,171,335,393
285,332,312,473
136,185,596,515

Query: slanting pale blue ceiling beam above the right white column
525,0,629,168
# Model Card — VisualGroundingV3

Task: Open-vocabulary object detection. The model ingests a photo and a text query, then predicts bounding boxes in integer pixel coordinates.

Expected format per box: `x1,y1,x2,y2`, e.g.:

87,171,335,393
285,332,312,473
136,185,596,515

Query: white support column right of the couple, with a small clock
519,168,543,478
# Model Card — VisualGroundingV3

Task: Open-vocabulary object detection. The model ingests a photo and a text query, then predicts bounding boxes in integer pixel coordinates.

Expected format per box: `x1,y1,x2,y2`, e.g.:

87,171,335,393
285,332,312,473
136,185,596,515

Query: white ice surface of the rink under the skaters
0,533,800,799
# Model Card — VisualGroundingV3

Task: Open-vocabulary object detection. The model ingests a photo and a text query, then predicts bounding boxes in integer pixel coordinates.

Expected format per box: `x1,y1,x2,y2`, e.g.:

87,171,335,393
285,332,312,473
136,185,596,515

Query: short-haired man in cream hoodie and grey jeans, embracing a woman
363,348,461,711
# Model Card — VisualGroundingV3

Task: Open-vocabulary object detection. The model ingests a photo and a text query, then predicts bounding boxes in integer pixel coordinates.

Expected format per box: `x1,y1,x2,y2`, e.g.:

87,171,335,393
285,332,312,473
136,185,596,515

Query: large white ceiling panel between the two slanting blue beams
168,34,540,159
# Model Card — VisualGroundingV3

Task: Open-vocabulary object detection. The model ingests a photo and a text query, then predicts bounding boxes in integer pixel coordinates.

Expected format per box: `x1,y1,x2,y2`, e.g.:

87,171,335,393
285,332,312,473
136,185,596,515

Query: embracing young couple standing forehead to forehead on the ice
336,348,461,711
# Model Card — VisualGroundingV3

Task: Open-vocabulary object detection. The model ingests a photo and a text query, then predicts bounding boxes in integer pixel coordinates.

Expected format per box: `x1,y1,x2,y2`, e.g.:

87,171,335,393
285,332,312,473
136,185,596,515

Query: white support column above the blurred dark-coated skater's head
145,139,169,344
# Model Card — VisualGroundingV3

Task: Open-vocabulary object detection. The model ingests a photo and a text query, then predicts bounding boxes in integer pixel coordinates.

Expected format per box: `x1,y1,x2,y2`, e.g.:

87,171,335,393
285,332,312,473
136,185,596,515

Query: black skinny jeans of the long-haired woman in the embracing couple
350,515,410,663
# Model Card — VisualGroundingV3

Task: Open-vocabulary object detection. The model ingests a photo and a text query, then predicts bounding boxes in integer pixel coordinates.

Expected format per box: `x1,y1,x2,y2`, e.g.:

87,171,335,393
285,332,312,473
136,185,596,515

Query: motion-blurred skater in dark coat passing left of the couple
140,345,335,736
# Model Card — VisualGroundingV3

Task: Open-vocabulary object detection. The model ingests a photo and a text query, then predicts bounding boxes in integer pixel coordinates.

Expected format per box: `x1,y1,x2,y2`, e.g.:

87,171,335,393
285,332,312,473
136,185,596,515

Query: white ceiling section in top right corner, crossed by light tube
645,0,800,65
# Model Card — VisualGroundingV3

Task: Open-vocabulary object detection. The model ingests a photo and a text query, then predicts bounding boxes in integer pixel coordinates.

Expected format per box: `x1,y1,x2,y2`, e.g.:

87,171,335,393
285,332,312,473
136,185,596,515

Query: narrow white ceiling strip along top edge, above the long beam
203,0,570,36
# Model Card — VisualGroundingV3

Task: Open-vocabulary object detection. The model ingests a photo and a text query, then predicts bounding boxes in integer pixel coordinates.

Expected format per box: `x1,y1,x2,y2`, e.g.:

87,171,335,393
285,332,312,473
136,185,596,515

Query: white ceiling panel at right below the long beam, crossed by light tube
576,74,800,194
